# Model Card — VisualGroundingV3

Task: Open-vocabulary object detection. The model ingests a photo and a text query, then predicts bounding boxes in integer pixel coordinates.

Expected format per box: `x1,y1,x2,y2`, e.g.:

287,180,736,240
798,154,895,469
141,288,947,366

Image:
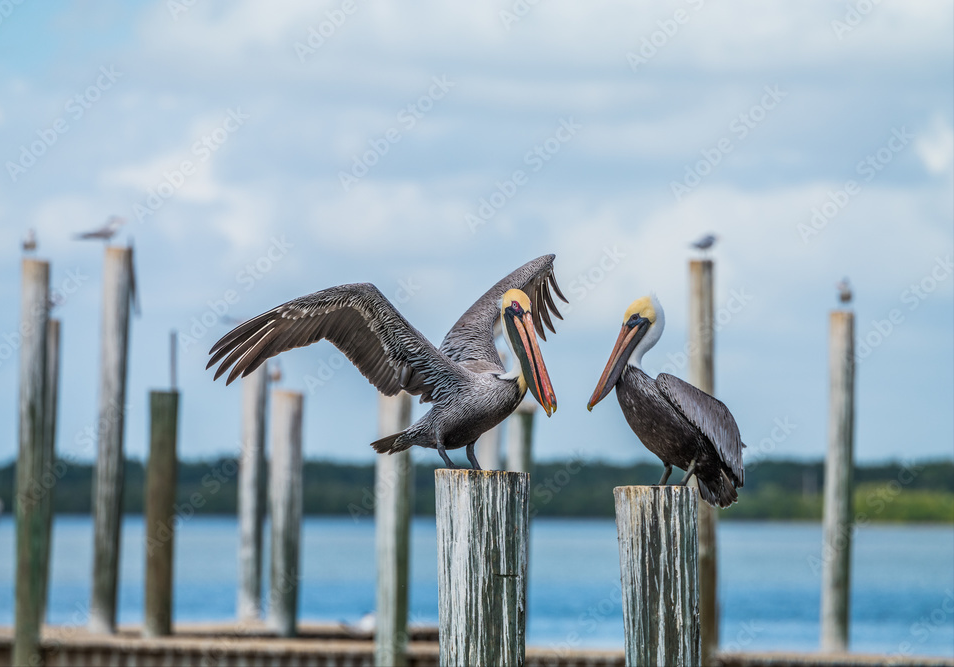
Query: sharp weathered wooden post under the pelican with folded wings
613,485,702,667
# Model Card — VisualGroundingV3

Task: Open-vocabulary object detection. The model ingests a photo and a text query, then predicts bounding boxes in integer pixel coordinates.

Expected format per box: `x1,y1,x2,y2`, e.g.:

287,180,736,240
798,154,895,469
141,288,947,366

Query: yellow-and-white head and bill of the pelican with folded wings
586,295,666,410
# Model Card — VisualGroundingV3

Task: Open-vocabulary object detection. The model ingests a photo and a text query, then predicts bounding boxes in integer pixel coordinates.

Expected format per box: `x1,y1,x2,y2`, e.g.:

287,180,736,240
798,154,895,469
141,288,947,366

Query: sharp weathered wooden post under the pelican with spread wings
434,469,530,667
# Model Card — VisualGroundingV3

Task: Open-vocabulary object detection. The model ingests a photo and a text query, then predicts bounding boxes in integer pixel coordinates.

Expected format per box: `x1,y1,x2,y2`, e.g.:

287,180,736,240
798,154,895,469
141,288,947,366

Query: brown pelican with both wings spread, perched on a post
207,255,566,470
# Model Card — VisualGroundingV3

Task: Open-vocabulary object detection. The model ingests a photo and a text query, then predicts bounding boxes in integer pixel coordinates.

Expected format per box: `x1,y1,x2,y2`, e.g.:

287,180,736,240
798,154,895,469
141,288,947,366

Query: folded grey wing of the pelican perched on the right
656,373,745,487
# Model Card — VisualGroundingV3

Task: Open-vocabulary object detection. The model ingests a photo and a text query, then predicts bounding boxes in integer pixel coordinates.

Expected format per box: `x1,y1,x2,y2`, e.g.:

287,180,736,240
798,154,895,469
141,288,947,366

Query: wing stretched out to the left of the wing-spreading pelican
206,283,465,402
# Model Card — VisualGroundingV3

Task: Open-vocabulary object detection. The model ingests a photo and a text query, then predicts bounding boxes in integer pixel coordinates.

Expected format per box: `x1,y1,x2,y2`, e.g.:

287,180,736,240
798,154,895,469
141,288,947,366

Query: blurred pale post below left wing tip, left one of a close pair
238,364,268,621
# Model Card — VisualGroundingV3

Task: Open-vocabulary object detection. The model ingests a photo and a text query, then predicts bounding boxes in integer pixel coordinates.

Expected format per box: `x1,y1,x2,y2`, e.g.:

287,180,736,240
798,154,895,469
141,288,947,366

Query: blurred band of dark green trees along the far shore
0,458,954,523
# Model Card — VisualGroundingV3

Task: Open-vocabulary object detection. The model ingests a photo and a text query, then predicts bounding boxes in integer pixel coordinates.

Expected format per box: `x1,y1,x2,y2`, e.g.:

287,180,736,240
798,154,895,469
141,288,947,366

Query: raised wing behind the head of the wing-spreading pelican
440,255,569,366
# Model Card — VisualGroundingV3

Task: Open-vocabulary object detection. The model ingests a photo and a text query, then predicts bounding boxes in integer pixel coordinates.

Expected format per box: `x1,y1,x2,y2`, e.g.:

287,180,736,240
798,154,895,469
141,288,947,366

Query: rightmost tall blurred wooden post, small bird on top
821,310,855,651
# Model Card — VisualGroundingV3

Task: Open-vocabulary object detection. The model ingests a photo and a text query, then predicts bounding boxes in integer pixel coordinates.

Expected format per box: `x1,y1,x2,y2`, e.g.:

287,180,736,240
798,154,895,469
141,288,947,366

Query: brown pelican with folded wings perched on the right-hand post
586,296,745,507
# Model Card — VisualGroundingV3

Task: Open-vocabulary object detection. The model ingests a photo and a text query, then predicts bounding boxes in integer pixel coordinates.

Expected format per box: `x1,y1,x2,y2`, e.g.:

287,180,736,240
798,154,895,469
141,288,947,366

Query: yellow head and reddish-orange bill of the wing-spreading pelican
500,289,556,417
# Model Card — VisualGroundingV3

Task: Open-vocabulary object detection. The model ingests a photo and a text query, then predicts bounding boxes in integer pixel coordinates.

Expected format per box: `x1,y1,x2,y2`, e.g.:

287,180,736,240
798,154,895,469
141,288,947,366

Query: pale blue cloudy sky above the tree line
0,0,954,464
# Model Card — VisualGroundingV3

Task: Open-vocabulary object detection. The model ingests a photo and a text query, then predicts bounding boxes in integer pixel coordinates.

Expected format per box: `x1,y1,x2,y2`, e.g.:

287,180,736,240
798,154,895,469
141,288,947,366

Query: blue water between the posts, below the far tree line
0,515,954,656
